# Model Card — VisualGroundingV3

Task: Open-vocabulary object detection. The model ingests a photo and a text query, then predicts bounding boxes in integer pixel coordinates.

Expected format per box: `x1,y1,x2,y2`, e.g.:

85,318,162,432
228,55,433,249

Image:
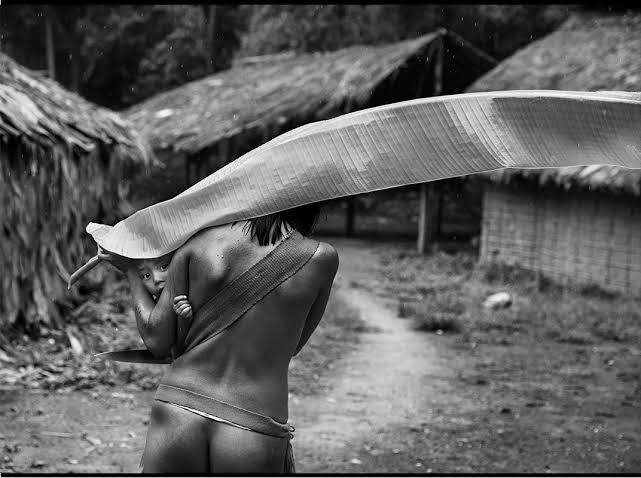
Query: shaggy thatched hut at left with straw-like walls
0,54,152,324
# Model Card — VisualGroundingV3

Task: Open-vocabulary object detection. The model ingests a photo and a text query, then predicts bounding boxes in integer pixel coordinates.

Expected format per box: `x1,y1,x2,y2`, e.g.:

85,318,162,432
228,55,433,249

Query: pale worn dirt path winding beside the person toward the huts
290,240,466,473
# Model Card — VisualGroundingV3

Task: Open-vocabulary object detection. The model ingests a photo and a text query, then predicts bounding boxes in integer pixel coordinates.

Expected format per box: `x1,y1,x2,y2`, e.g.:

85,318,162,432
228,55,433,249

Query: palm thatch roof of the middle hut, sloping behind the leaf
125,29,496,159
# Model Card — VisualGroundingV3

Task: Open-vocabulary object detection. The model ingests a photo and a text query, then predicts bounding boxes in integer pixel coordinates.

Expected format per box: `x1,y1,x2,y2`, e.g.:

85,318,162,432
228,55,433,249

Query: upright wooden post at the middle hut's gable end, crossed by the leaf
416,35,445,254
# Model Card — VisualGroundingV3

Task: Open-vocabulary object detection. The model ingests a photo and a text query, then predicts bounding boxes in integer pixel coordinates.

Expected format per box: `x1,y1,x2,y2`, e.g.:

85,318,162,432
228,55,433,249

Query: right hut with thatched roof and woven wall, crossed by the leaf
468,13,641,296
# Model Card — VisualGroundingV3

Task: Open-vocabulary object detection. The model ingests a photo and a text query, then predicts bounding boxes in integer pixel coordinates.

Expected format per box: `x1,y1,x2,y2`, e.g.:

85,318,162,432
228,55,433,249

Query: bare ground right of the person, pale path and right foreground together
292,240,641,473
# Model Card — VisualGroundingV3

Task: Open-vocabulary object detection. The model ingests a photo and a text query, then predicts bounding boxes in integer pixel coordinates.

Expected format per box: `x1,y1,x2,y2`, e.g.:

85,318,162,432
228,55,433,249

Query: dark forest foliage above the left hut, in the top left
0,5,242,109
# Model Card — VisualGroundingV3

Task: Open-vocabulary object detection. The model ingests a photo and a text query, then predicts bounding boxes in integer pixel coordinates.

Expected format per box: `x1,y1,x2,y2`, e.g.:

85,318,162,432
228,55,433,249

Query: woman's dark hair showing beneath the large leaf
238,202,323,246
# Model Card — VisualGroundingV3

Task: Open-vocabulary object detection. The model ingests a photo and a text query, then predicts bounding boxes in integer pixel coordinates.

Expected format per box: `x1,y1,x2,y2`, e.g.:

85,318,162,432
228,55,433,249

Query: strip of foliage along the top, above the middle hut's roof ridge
242,4,575,58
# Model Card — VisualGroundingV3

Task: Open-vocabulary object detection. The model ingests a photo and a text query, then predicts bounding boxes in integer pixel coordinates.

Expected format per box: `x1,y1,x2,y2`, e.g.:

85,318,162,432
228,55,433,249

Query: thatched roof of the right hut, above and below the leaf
467,13,641,196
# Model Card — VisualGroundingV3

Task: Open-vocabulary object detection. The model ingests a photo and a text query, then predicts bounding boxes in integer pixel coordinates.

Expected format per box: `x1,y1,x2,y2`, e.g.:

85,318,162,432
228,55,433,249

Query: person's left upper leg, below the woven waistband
143,400,210,474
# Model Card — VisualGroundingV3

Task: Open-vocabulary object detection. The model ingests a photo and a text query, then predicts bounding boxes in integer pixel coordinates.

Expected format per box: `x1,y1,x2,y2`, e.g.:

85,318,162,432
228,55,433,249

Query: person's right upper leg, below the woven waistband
209,420,288,474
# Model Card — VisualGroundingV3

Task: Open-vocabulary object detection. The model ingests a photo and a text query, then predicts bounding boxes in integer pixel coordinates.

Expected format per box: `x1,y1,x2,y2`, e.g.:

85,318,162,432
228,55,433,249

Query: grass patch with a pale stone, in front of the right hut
364,244,641,346
